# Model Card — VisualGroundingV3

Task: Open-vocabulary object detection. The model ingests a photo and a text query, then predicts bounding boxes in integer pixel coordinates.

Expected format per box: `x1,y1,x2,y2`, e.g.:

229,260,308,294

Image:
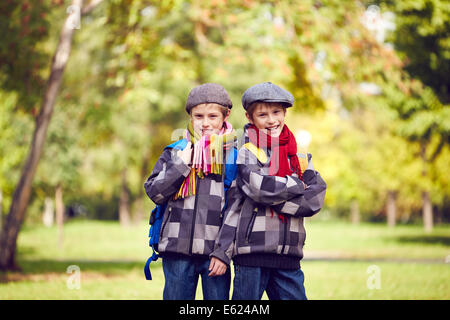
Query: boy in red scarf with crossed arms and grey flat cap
211,82,326,300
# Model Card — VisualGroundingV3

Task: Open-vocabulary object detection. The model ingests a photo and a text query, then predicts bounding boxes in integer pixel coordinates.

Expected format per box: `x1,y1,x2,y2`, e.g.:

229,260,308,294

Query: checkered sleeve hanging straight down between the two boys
210,180,245,265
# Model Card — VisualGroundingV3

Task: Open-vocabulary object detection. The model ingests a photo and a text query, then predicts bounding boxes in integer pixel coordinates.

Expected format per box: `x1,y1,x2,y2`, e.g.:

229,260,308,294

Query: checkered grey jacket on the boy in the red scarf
211,136,326,264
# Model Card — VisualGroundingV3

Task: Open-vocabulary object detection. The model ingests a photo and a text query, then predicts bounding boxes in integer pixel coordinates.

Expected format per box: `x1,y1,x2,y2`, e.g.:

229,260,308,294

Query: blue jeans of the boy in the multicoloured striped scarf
162,257,231,300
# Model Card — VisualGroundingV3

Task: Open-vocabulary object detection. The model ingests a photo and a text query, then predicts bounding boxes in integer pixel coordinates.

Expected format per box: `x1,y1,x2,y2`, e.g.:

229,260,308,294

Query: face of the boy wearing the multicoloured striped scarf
191,104,230,136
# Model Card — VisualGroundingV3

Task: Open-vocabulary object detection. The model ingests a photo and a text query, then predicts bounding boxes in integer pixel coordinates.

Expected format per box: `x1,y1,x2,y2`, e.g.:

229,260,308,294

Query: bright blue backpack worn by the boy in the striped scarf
144,139,237,280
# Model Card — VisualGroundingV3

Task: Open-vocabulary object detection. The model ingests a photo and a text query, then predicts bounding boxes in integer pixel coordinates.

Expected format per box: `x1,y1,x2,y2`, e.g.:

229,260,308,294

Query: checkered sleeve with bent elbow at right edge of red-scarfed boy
272,169,327,217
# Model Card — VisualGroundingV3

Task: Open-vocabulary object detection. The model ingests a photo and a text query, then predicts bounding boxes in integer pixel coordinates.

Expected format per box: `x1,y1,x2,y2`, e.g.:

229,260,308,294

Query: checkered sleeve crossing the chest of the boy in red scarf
237,147,305,206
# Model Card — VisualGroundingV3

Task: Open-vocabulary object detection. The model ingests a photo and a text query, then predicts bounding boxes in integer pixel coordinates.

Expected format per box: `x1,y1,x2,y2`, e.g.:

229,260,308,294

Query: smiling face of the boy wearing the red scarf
245,103,286,137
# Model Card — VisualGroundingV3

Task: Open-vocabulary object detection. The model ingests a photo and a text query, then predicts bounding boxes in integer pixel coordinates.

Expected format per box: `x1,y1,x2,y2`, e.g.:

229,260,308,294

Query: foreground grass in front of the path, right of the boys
302,261,450,300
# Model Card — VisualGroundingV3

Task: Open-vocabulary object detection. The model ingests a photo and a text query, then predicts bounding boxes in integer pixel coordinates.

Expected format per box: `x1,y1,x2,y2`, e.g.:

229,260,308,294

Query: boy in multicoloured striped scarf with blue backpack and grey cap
145,83,237,300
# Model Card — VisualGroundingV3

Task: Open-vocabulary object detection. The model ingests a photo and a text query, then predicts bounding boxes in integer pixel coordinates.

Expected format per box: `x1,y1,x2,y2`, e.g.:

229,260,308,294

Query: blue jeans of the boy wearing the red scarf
233,265,307,300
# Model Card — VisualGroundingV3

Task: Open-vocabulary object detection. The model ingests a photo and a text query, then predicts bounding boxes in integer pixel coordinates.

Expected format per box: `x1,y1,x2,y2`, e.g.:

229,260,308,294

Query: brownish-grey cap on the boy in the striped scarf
186,83,233,113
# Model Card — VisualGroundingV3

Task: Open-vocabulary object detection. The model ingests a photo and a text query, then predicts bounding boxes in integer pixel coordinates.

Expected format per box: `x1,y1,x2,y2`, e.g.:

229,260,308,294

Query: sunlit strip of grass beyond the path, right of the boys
305,220,450,262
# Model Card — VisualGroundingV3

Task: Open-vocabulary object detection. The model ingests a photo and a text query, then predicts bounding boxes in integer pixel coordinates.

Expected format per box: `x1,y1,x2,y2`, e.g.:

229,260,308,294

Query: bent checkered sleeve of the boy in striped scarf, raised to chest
144,149,191,204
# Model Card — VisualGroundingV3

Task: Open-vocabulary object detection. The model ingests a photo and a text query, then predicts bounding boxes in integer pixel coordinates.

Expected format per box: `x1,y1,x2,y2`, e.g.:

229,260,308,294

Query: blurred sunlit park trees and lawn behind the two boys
0,0,450,298
